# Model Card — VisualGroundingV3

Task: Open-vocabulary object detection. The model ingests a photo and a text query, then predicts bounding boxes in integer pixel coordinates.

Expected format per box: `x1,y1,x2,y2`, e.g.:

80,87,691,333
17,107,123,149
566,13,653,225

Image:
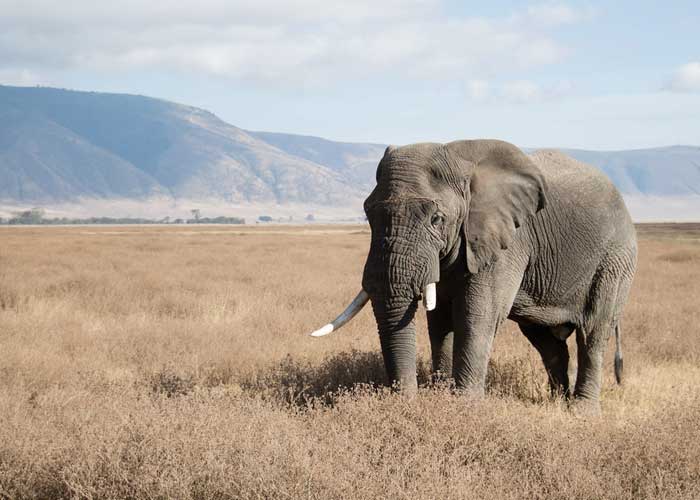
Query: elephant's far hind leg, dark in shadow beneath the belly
519,324,574,399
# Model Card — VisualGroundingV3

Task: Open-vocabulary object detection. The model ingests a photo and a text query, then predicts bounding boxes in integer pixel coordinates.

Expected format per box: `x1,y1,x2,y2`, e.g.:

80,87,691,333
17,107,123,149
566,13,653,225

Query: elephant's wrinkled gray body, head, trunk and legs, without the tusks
362,140,637,413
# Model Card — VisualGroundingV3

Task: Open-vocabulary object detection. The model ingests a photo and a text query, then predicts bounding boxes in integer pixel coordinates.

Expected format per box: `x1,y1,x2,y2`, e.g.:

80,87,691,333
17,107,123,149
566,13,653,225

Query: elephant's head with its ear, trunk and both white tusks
312,140,546,391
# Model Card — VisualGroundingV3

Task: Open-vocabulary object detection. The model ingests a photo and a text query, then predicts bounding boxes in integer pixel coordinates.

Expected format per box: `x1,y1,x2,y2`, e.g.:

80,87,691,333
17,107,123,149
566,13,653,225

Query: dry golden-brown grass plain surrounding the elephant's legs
0,226,700,499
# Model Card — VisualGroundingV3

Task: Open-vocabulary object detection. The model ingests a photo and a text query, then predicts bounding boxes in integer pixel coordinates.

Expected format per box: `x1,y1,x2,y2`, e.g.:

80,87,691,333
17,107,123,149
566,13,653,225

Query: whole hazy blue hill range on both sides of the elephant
0,86,700,221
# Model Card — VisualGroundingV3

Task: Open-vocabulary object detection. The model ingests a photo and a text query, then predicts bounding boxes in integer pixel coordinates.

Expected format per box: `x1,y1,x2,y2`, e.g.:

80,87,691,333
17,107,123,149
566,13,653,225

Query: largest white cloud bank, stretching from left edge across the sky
0,0,578,86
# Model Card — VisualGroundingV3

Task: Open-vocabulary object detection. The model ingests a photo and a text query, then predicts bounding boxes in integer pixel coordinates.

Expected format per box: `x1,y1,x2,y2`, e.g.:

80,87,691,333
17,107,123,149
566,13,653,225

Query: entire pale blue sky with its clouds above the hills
0,0,700,149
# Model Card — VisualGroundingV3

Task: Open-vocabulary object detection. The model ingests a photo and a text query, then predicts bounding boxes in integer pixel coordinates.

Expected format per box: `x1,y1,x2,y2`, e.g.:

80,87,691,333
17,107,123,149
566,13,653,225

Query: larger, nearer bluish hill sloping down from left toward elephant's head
0,87,370,205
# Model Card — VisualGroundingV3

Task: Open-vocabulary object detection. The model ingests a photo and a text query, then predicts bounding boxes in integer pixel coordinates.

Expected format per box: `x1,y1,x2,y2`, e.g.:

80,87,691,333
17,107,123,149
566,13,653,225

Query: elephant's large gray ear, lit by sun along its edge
448,141,547,273
